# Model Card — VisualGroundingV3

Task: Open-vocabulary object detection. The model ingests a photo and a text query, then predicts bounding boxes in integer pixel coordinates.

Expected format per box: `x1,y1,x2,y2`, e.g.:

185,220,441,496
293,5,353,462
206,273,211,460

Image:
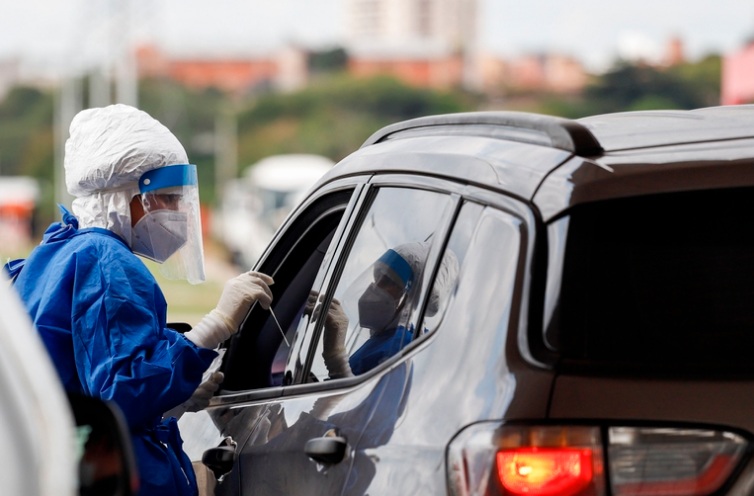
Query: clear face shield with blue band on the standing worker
131,164,204,284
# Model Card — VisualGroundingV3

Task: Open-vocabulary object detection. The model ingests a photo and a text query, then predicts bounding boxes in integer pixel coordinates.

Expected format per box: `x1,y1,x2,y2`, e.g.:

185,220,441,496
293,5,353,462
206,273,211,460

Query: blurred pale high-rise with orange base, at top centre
345,0,478,87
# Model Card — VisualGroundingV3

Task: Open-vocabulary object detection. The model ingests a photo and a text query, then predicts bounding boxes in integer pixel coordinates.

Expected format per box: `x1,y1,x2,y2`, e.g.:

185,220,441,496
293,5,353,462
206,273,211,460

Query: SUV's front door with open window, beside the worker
179,179,367,494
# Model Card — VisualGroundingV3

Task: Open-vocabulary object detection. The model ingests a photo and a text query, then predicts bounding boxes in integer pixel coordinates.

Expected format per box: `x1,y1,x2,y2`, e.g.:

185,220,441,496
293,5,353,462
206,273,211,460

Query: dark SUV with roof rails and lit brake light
181,106,754,496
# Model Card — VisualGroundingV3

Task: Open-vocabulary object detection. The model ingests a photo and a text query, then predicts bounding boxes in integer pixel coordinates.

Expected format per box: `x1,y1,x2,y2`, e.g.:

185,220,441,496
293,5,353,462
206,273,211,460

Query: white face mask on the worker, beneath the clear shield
131,210,188,263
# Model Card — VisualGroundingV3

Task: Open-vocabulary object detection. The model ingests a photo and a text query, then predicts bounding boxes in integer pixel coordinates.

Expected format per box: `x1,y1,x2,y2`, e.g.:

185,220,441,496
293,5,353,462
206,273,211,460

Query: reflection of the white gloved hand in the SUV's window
305,291,353,379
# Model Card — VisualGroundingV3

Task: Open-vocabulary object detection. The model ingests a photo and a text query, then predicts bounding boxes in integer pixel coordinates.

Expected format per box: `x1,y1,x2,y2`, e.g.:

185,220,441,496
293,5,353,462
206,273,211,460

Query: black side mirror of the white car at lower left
68,394,139,496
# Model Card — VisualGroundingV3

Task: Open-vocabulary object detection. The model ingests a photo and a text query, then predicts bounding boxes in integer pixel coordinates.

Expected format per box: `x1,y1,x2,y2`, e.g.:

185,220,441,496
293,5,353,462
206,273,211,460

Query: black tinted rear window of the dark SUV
546,188,754,375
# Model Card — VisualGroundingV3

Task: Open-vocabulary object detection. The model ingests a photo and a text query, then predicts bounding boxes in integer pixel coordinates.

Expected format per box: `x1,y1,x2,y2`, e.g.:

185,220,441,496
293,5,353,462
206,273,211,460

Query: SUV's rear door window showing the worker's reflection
310,187,455,381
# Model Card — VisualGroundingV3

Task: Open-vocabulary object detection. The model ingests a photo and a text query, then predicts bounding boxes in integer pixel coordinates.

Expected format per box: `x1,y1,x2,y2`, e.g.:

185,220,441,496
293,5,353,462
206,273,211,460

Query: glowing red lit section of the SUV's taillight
497,448,594,496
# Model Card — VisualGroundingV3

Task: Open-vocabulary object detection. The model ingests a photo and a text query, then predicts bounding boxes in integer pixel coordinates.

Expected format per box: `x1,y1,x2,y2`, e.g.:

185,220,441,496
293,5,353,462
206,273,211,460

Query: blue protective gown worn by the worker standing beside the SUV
10,209,216,496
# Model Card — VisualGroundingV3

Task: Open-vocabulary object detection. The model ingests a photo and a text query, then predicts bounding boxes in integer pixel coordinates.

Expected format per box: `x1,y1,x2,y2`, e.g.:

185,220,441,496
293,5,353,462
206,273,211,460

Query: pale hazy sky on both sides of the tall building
0,0,754,74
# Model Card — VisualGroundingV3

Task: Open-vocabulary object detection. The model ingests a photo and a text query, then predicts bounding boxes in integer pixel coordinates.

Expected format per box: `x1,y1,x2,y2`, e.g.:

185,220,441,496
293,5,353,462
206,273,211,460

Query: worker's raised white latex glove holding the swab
184,272,275,349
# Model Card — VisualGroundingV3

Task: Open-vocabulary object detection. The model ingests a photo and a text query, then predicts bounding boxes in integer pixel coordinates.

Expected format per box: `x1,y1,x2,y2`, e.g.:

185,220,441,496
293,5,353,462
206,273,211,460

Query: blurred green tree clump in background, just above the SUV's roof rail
238,75,476,167
